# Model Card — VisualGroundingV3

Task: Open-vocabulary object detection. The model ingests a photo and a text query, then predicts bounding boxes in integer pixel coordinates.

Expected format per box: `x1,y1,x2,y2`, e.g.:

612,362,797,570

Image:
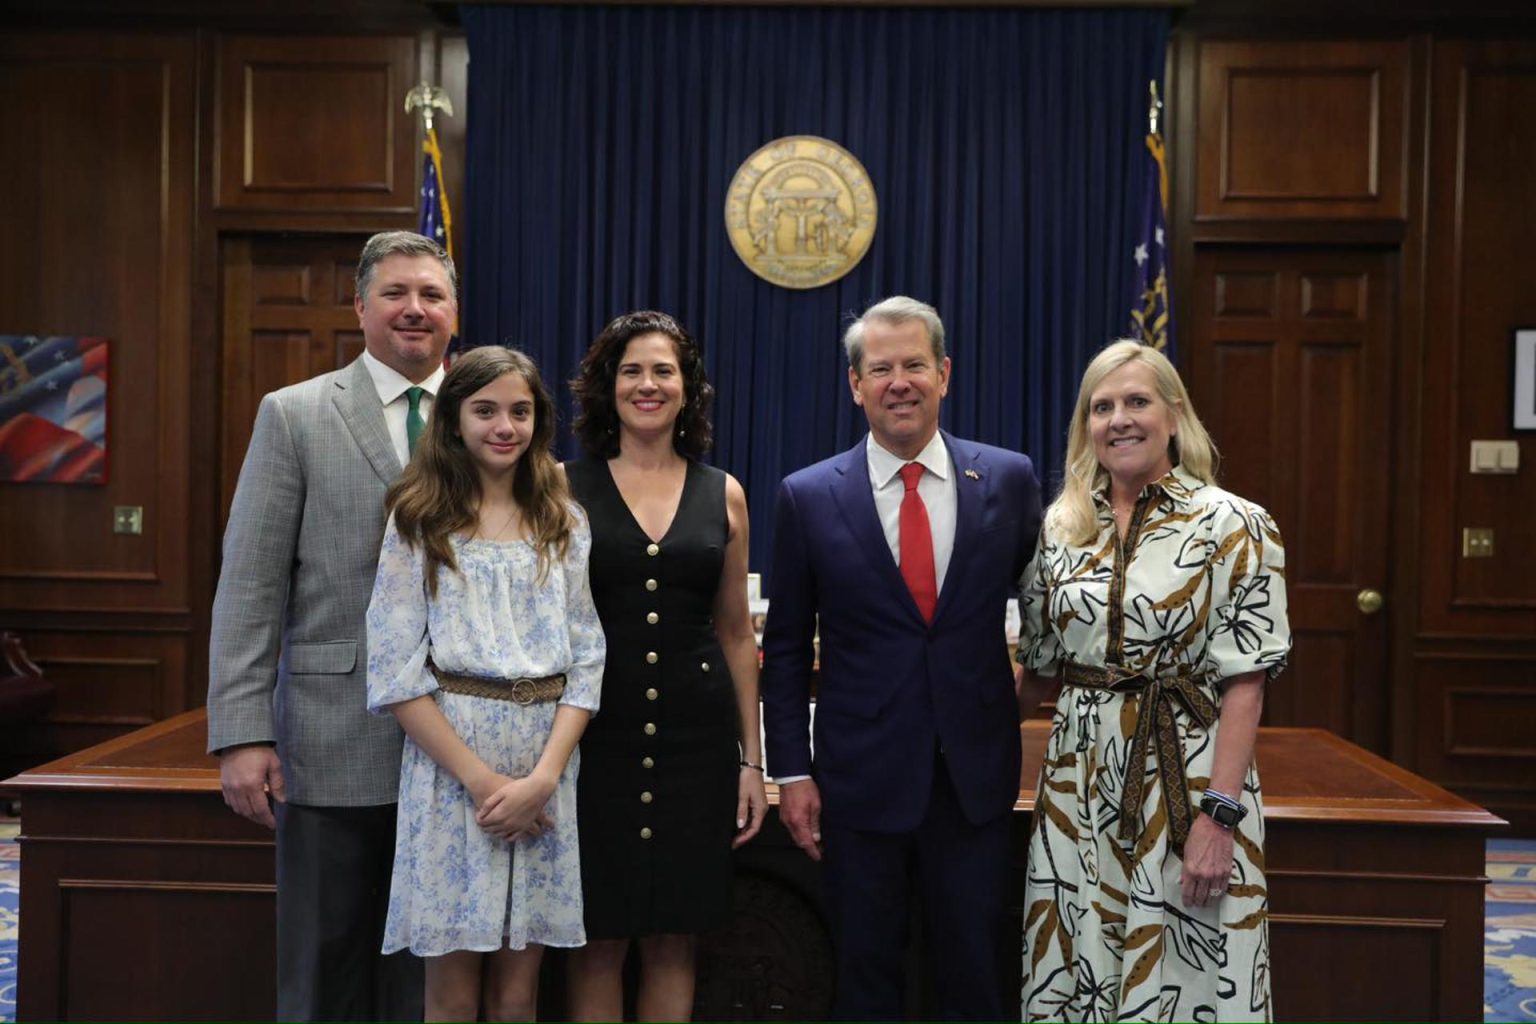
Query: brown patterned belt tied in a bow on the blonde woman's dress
1063,663,1220,855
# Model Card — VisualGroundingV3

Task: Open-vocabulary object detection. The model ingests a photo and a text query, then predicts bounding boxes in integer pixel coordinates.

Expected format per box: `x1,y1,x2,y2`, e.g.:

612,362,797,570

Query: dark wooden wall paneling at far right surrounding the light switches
1404,35,1536,834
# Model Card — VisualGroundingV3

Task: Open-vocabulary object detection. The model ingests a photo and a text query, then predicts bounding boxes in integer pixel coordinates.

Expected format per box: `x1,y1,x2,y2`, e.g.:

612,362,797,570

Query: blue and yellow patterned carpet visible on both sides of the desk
0,818,1536,1024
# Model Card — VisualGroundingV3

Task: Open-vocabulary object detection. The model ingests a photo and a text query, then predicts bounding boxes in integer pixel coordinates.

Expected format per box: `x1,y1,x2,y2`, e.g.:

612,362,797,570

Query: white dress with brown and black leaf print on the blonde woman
1018,468,1290,1021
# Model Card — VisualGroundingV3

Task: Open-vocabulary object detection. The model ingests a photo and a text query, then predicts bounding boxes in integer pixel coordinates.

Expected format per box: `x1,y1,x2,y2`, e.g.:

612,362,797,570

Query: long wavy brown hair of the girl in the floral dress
384,345,574,597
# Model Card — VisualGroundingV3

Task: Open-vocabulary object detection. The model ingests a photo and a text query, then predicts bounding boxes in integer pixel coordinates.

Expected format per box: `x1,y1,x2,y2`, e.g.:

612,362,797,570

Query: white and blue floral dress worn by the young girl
367,505,604,956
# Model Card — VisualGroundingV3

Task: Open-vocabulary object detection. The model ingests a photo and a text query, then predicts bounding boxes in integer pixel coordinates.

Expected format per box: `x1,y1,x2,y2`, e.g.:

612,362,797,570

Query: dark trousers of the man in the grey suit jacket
276,803,422,1021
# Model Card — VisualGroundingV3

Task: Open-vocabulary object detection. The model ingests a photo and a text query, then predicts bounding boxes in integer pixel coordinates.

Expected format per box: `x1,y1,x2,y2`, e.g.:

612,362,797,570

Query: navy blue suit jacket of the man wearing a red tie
762,433,1040,832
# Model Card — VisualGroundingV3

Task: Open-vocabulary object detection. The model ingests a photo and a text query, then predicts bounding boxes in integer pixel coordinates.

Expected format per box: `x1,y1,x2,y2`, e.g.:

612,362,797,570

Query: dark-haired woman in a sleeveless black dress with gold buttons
567,312,768,1021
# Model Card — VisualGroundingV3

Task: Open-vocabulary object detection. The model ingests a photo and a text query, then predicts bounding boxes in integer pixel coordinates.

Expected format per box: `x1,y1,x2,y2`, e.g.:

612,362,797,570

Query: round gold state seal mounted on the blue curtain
725,135,877,289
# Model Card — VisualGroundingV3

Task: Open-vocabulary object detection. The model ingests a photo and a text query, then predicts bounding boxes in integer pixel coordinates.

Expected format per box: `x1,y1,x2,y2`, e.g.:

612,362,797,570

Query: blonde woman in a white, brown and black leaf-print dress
1018,341,1290,1021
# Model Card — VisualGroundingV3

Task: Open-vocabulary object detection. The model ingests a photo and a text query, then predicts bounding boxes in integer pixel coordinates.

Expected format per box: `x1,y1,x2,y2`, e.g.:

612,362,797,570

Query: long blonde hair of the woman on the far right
1046,338,1218,545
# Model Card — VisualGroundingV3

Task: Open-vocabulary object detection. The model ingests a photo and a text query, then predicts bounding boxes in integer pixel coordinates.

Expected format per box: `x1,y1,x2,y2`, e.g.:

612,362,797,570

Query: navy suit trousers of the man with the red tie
822,758,1018,1021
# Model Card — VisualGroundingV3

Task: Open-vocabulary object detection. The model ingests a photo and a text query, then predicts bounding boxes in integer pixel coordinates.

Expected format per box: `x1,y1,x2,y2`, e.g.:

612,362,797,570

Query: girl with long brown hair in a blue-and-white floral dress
367,347,604,1021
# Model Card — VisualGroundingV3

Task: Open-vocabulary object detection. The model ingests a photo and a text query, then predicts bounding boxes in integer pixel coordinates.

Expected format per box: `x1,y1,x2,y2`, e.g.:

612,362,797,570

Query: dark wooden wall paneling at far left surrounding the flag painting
0,34,197,611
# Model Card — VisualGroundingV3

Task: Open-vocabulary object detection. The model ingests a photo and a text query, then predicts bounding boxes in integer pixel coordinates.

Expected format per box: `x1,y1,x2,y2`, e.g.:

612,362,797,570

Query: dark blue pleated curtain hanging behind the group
462,5,1167,571
